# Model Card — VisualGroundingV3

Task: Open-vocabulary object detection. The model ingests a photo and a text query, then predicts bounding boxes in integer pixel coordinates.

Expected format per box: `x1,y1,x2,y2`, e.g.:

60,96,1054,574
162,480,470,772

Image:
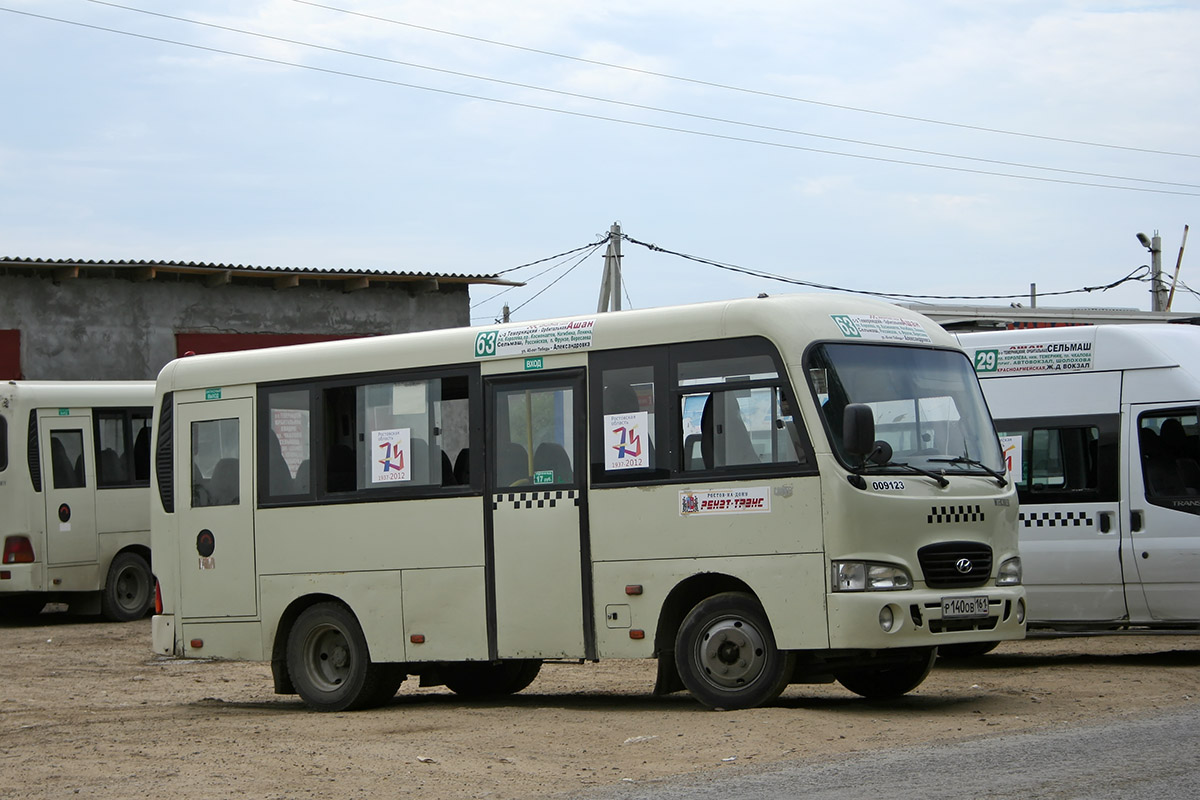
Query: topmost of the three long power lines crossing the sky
293,0,1200,158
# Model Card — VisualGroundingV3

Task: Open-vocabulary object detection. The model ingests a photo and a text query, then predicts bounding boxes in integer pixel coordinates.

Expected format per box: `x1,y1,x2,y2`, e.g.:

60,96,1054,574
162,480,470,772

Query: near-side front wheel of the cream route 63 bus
674,591,796,709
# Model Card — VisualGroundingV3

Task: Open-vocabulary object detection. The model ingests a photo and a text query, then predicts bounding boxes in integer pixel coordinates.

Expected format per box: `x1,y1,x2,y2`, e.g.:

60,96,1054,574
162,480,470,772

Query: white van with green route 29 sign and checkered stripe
959,325,1200,631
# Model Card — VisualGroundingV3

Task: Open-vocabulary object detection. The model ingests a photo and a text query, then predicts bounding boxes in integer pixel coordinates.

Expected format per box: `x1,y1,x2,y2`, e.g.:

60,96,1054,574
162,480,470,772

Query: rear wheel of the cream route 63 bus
287,602,388,711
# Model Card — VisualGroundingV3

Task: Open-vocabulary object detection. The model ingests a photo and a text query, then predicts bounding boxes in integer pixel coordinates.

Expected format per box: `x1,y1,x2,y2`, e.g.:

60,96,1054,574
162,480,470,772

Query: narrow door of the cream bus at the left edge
38,417,98,567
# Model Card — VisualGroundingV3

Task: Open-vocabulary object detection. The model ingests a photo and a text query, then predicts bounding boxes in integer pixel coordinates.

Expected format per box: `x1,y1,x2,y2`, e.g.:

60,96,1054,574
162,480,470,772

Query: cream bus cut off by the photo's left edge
0,380,154,620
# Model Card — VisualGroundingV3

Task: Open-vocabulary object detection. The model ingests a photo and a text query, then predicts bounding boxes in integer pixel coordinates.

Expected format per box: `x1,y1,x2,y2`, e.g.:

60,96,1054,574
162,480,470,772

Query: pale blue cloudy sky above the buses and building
0,0,1200,323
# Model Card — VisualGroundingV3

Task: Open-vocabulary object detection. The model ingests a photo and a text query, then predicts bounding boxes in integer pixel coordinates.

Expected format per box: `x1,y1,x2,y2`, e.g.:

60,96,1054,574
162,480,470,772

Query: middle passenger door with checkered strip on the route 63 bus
485,369,594,658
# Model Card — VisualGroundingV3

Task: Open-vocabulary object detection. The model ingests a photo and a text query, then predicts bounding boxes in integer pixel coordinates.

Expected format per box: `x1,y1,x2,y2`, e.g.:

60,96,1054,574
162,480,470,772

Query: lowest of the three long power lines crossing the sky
0,8,1200,197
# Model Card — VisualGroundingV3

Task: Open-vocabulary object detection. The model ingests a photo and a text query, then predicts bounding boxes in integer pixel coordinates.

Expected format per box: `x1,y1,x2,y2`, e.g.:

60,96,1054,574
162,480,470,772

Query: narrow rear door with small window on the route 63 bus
175,398,258,618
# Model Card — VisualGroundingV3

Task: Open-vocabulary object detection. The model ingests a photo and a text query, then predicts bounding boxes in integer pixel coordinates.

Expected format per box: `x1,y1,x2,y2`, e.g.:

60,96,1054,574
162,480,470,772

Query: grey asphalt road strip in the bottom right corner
569,705,1200,800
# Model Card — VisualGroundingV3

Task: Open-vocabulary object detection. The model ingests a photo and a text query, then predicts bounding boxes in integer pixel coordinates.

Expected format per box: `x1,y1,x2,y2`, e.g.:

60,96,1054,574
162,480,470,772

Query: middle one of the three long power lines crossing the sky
72,0,1200,188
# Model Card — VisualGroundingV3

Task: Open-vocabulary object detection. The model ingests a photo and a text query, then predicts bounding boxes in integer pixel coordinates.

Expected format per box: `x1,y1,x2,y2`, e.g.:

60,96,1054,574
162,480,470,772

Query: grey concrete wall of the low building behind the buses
0,275,470,380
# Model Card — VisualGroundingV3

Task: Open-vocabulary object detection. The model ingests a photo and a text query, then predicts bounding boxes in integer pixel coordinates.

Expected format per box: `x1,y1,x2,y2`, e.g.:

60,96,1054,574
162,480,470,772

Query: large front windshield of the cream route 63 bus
808,344,1004,473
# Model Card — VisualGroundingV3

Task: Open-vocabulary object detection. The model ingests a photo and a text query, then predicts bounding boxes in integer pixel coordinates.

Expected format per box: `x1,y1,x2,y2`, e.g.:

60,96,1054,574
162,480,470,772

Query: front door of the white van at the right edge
1127,404,1200,622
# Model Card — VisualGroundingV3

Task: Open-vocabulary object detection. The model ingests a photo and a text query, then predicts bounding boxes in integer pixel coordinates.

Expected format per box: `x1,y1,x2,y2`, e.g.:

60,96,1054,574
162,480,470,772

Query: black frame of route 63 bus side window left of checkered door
254,365,484,509
